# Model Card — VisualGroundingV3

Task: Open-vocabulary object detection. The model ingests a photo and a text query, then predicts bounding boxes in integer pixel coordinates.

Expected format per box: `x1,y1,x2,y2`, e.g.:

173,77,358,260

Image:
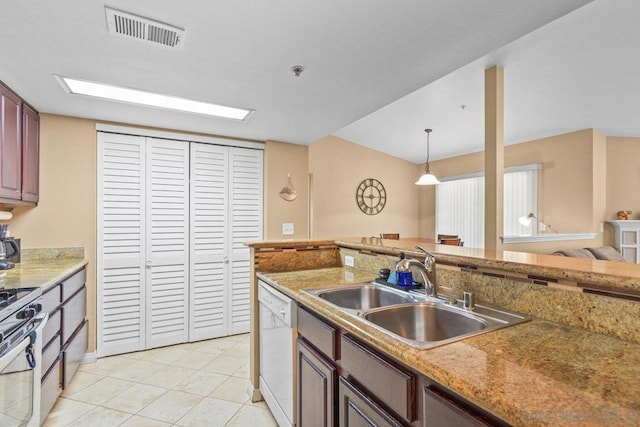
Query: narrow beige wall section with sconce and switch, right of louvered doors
264,141,309,240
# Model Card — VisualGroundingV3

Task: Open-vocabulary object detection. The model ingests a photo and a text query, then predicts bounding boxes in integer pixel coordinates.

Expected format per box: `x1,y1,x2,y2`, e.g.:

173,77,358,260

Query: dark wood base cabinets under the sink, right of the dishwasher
296,308,508,427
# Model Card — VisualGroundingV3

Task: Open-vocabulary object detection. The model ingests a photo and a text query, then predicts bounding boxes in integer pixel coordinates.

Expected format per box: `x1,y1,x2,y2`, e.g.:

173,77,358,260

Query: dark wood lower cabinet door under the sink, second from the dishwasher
338,378,400,427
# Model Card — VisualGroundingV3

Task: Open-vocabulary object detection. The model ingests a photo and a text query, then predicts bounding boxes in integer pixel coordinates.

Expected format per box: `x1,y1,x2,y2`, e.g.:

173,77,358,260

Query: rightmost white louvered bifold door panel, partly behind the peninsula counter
228,147,263,334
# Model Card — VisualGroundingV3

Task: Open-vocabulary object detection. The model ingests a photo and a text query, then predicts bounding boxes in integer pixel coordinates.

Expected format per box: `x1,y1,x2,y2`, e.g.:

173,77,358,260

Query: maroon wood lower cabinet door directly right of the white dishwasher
297,339,337,427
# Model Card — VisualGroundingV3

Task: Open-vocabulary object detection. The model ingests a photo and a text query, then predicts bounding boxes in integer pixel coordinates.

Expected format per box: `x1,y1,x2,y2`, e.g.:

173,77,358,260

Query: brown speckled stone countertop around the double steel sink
258,267,640,426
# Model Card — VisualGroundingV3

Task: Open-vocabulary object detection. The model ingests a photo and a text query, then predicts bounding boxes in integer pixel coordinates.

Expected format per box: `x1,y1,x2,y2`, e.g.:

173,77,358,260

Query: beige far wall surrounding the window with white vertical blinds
420,129,606,252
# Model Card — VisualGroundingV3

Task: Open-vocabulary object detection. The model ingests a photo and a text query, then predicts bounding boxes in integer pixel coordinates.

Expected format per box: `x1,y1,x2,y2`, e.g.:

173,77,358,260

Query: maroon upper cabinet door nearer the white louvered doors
22,104,40,203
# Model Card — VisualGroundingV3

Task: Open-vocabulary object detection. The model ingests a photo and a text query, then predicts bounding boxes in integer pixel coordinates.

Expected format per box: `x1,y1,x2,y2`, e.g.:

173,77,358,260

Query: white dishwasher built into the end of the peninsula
258,281,298,427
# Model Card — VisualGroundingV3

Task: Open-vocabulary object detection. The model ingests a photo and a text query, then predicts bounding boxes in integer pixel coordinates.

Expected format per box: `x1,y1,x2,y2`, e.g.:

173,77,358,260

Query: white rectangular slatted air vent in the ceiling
104,7,185,48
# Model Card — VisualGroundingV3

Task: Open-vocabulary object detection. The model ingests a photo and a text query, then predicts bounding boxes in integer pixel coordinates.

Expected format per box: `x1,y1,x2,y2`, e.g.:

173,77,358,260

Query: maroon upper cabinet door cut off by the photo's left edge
0,84,22,200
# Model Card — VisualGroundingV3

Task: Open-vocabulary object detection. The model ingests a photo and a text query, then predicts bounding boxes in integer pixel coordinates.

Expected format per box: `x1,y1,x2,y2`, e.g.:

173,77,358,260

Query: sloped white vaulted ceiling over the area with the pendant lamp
333,0,640,163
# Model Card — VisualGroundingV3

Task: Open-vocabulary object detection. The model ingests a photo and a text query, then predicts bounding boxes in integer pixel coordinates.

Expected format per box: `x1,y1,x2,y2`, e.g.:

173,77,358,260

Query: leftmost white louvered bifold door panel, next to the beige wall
97,132,146,356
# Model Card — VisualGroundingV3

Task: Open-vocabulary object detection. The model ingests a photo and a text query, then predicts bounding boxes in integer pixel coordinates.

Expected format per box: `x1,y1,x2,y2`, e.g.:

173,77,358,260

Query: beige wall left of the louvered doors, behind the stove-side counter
9,114,96,352
